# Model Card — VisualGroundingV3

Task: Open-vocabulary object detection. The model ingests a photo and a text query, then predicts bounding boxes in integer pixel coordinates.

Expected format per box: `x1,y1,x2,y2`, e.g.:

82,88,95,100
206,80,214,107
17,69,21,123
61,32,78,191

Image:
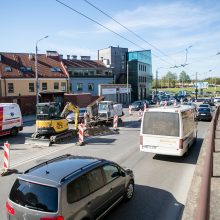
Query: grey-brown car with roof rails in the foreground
6,154,134,220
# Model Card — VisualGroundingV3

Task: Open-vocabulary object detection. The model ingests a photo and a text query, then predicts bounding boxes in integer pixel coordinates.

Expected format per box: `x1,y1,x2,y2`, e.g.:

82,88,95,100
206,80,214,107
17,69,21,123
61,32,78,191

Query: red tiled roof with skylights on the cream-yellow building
0,52,68,78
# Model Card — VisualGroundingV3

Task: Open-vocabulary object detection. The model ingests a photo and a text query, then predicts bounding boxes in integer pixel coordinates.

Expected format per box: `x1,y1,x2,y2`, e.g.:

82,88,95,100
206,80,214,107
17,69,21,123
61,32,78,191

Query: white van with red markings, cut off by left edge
0,103,23,136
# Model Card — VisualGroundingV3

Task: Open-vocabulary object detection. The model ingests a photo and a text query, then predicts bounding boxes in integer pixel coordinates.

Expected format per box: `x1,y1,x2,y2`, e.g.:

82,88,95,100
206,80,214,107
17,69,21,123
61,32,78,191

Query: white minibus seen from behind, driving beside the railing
140,105,197,156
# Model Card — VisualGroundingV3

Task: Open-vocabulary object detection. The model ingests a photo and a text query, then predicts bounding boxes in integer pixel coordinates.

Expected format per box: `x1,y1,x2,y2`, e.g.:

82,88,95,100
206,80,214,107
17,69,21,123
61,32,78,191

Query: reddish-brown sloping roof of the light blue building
63,59,107,68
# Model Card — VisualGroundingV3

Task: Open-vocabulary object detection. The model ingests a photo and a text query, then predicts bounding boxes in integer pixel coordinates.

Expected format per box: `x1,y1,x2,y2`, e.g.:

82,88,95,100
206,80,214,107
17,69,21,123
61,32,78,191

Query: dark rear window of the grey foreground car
9,179,58,212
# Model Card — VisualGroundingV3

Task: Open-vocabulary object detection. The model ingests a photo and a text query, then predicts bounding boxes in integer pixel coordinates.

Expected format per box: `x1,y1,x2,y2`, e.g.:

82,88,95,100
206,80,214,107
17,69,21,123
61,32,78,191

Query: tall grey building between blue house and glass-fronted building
98,46,128,83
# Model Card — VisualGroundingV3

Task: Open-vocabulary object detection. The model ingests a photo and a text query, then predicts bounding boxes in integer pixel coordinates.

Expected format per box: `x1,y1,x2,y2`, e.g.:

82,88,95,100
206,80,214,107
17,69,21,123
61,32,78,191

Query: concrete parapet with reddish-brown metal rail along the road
182,107,220,220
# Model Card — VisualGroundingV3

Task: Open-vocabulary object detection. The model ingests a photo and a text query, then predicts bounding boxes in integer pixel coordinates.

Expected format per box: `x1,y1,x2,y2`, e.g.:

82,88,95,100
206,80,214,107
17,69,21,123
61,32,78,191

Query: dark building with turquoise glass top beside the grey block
127,50,152,101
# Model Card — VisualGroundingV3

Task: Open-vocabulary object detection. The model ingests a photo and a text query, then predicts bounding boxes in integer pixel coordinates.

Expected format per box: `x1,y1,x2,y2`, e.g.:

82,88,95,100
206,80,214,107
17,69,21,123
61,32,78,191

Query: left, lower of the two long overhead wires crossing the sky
55,0,173,65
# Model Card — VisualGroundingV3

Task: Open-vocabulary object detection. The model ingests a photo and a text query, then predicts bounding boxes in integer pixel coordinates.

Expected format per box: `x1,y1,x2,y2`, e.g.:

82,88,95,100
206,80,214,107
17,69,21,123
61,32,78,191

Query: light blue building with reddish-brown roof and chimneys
63,56,114,95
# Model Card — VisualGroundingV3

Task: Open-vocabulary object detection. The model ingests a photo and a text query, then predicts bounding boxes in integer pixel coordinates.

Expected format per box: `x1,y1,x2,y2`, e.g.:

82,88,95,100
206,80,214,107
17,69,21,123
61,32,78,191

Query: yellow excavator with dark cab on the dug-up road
25,102,79,146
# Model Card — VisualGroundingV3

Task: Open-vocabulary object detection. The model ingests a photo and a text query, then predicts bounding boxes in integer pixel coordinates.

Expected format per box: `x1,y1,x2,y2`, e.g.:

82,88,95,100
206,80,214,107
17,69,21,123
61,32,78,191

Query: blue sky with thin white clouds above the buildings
0,0,220,79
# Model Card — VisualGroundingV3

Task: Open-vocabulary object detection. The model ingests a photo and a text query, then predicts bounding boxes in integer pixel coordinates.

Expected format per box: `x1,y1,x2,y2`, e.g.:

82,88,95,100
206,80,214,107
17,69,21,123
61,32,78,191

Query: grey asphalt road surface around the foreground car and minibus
0,114,209,220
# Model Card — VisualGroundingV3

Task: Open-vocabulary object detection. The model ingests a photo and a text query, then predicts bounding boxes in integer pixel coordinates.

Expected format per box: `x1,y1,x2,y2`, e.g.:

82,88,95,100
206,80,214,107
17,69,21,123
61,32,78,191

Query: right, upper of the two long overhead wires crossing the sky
84,0,176,63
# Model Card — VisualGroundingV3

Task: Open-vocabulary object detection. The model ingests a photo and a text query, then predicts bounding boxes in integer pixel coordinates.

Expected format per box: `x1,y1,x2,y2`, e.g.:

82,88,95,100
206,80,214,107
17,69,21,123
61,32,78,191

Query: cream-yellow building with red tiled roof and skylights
0,51,68,101
